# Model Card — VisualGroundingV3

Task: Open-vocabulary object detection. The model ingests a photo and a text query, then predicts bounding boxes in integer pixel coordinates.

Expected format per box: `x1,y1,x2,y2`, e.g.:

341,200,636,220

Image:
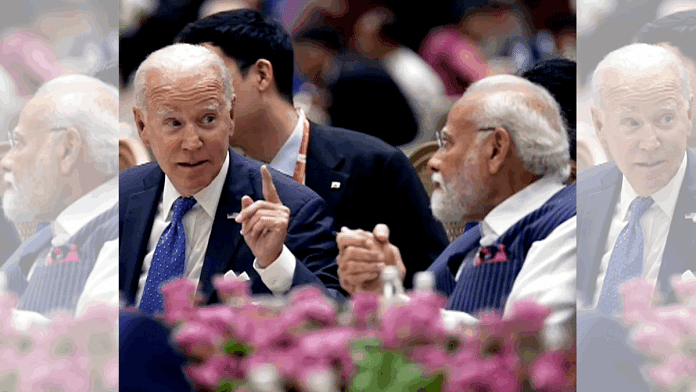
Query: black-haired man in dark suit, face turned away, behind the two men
177,10,447,291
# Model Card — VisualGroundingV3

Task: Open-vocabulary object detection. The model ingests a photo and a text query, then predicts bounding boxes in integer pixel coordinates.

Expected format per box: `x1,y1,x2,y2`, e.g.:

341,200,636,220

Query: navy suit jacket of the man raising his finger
119,150,340,304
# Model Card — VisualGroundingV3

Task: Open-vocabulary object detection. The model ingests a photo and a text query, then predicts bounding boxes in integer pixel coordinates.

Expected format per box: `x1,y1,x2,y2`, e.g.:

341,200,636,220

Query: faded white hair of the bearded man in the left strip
35,75,119,177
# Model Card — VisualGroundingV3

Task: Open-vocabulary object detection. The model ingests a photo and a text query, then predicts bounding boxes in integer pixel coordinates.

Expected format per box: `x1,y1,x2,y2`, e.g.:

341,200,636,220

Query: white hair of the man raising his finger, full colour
135,44,234,115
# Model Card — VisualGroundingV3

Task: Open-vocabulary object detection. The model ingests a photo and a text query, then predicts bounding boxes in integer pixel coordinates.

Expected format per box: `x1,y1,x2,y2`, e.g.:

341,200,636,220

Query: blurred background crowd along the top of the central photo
120,0,576,152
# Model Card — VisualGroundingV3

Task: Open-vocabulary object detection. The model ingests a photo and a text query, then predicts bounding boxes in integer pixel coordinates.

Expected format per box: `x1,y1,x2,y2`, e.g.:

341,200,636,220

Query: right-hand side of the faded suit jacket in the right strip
657,149,696,301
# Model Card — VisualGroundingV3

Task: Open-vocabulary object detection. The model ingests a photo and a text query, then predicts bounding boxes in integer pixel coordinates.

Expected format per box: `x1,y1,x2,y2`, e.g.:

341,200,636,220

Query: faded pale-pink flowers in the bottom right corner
619,277,696,391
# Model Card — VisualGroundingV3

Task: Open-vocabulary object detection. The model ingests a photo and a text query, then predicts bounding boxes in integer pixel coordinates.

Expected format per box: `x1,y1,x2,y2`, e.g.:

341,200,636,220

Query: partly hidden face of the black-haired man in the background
202,44,260,145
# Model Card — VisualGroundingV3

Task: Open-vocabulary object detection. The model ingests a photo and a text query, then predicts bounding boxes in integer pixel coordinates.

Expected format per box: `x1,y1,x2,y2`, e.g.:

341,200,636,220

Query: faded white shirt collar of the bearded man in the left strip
51,176,118,246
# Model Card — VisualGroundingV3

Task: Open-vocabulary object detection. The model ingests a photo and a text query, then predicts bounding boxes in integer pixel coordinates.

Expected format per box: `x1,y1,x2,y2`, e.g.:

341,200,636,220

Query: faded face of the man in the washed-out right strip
593,68,691,197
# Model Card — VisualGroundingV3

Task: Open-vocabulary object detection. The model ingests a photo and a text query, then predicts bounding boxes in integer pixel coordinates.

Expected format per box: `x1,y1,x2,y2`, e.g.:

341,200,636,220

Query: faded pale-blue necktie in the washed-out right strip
597,197,653,315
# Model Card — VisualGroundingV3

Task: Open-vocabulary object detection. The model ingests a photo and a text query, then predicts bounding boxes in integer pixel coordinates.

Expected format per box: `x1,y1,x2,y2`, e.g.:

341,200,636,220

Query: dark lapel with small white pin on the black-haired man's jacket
305,123,349,210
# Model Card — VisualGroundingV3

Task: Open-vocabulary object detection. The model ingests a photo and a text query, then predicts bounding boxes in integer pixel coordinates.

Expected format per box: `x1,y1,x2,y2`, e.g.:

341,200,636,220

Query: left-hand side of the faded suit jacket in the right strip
577,166,621,303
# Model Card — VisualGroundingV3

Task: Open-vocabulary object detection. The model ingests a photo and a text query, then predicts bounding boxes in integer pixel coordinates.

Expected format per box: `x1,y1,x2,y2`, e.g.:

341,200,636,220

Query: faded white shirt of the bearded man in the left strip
13,177,119,328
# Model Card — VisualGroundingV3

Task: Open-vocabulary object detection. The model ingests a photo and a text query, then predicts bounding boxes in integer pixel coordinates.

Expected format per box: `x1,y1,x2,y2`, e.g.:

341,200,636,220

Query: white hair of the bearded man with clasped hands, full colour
464,75,570,180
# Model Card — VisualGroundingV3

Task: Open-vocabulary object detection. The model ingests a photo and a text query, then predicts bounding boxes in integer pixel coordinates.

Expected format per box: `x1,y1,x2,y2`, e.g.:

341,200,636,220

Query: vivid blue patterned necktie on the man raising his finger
140,197,196,315
